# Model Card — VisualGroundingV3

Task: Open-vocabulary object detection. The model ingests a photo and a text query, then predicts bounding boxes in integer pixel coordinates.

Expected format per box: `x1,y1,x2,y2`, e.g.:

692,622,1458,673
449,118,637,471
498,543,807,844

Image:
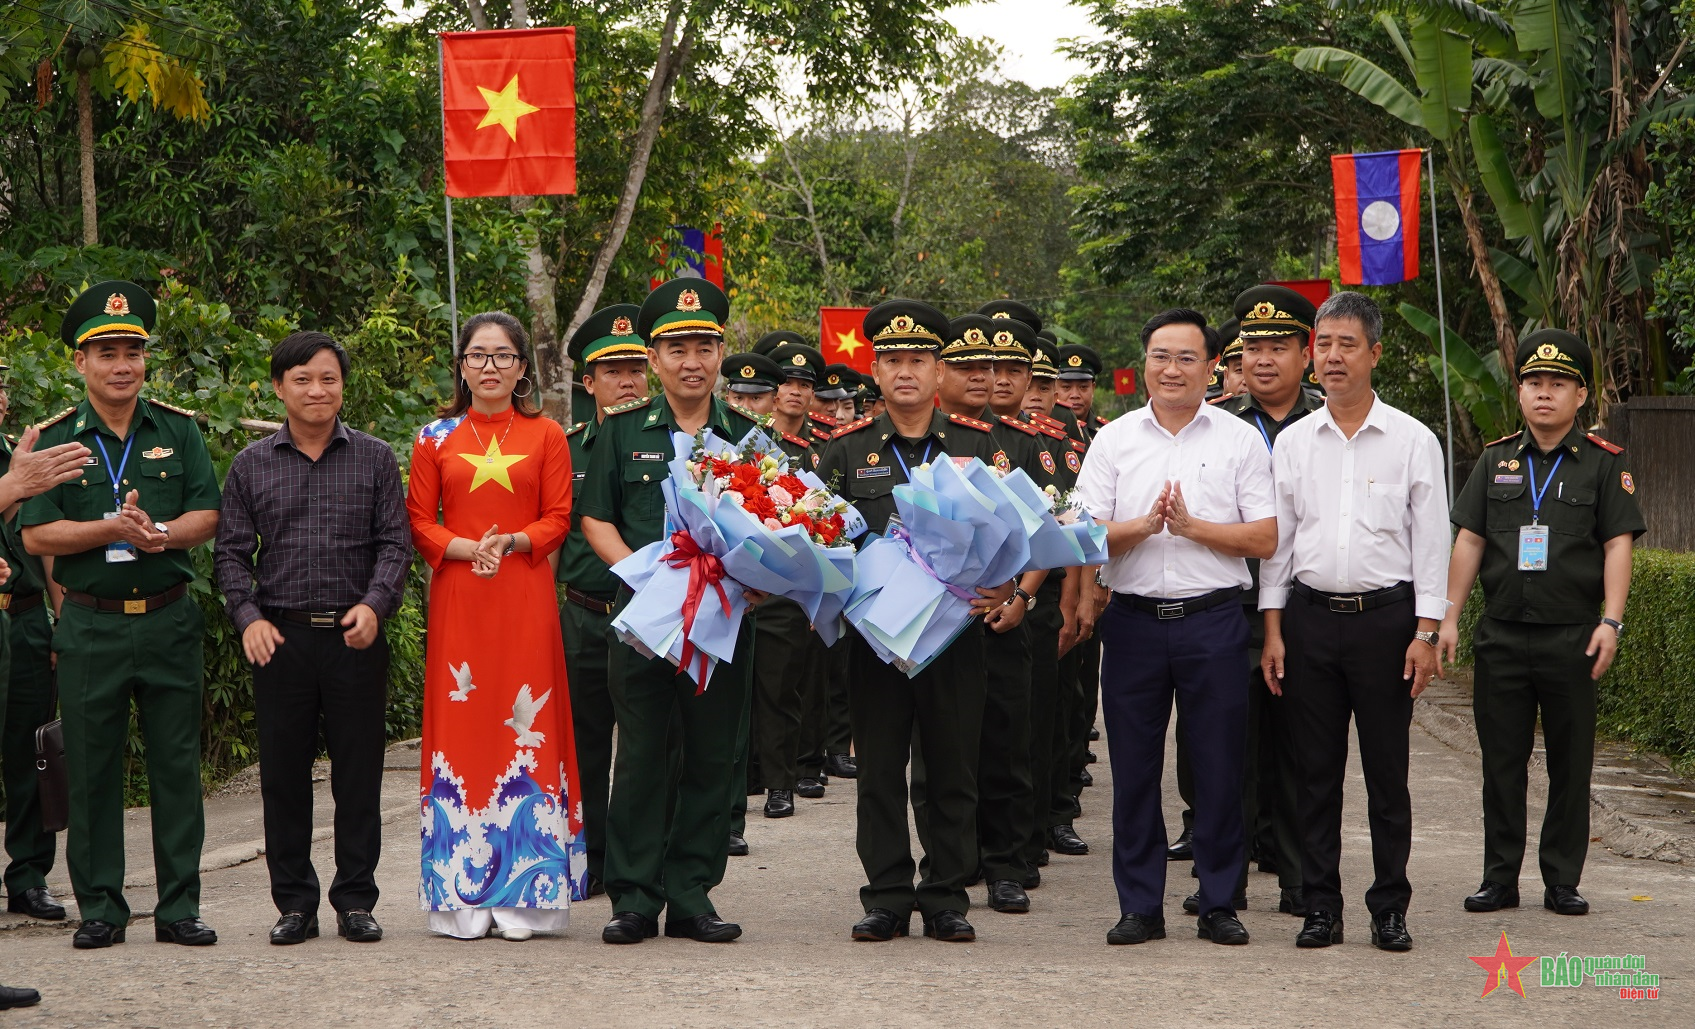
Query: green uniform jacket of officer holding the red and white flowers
576,395,758,556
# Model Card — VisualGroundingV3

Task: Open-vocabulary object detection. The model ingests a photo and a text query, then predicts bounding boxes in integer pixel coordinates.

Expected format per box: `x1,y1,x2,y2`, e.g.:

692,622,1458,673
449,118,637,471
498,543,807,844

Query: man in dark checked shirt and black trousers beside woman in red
215,332,412,944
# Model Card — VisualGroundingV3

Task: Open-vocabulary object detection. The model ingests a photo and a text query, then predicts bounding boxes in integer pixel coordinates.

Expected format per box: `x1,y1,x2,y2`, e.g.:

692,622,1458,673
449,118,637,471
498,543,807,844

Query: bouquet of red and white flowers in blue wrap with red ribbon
612,429,864,692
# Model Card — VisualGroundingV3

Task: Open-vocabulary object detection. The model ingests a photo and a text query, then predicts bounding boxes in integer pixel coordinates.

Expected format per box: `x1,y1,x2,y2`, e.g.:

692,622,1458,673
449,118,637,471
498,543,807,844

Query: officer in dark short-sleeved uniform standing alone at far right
1441,329,1646,915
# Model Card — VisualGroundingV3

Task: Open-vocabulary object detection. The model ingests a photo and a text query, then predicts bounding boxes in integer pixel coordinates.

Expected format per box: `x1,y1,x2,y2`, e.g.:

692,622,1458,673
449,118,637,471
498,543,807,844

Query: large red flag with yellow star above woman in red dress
441,27,576,197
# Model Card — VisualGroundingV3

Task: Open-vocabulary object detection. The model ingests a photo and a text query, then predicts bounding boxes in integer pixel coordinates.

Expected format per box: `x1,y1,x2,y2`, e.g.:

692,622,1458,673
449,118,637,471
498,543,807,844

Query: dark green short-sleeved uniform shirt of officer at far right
1449,426,1648,626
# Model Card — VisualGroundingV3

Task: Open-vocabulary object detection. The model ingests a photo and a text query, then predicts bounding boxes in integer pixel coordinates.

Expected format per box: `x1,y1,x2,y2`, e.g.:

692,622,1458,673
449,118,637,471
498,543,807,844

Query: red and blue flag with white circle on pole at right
1331,151,1424,286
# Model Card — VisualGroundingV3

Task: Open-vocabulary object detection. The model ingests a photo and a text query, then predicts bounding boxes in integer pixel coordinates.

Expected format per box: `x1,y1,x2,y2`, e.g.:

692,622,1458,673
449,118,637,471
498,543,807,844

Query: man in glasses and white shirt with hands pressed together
1076,309,1276,944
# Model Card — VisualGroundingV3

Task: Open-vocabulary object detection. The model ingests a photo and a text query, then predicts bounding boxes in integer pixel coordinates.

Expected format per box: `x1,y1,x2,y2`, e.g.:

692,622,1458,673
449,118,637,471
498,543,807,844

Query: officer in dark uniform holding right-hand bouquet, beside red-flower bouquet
819,300,1014,941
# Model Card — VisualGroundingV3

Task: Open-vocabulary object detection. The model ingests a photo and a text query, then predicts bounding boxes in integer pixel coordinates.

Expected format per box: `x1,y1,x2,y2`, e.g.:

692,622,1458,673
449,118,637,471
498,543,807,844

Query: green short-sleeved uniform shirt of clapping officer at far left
19,400,219,600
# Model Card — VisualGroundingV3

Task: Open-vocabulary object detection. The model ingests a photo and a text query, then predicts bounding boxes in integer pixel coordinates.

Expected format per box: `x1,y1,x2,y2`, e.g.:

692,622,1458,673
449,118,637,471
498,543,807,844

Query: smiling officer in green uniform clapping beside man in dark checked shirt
19,281,219,949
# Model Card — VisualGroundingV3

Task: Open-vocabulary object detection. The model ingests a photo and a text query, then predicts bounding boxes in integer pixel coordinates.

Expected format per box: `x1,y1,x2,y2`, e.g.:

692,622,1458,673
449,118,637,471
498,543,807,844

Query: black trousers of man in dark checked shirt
253,622,388,915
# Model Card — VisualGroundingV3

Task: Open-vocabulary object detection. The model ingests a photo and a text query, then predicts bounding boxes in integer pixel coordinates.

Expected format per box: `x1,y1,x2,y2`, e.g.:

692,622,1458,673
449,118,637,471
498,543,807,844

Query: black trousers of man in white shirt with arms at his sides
1283,593,1419,915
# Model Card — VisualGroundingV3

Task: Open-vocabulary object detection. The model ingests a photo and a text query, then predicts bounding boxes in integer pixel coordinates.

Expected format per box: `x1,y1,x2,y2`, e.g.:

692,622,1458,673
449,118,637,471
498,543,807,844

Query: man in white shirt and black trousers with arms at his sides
1259,293,1448,951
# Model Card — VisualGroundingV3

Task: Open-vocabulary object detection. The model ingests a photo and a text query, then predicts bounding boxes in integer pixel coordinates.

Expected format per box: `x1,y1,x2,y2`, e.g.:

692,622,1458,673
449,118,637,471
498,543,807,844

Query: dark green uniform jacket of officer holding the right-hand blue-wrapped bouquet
819,410,1009,532
